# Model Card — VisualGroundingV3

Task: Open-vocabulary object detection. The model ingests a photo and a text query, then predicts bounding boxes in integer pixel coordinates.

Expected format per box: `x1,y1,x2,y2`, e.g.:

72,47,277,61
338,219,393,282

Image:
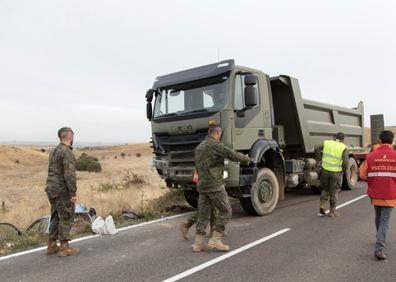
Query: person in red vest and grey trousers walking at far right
359,130,396,260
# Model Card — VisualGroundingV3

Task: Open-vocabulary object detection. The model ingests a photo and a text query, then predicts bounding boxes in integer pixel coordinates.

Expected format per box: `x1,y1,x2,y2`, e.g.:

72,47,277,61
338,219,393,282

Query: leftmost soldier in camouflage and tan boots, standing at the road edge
45,127,80,257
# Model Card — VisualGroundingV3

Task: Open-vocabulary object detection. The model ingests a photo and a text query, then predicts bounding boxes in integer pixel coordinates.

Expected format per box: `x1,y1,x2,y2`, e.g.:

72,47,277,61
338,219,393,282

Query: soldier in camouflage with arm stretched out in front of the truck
192,124,250,252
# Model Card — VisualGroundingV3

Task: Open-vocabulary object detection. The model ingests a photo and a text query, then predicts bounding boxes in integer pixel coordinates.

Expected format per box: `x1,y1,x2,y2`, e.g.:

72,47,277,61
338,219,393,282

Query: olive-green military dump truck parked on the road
146,60,364,215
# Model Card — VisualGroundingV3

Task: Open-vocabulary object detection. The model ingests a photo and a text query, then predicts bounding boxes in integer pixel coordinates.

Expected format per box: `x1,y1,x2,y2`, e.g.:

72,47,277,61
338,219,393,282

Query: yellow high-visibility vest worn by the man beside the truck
322,140,347,172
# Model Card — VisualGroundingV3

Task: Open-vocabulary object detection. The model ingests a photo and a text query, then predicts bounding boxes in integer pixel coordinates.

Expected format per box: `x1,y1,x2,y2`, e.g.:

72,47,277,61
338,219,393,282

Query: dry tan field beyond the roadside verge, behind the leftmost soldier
0,144,168,229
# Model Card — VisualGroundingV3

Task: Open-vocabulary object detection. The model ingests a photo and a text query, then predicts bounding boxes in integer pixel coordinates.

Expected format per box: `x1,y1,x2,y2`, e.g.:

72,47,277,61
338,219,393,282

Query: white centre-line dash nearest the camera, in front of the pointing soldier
162,228,291,282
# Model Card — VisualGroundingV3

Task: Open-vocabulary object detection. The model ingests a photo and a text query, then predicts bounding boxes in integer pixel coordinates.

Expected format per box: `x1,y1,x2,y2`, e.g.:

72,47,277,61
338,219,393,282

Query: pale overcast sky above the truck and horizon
0,0,396,142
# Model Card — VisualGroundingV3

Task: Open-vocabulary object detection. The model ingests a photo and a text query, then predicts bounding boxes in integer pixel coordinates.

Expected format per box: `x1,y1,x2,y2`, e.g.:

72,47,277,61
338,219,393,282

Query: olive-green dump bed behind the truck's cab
270,76,364,153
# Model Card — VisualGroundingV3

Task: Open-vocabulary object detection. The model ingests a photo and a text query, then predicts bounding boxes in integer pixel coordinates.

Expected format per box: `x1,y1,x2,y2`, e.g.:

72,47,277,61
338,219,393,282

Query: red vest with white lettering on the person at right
367,145,396,200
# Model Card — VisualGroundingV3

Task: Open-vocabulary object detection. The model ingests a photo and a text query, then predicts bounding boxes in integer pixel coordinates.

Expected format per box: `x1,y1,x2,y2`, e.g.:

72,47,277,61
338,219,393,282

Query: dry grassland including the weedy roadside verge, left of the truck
0,144,191,256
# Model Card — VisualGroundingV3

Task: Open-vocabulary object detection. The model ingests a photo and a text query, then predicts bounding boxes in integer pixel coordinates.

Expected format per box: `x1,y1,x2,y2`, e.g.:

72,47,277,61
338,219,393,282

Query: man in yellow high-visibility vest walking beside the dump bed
319,132,349,217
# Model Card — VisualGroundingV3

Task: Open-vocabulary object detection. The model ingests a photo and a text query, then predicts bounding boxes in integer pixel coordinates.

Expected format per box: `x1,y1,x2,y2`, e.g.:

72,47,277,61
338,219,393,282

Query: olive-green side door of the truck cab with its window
233,73,269,150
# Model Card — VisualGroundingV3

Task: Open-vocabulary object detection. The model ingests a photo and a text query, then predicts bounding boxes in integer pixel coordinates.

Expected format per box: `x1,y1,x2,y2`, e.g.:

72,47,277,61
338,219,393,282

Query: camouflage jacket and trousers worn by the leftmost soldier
45,143,77,241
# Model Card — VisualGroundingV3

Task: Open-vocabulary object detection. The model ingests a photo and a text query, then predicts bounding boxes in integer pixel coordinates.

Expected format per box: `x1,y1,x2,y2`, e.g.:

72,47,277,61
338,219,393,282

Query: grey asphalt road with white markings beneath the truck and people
0,184,396,281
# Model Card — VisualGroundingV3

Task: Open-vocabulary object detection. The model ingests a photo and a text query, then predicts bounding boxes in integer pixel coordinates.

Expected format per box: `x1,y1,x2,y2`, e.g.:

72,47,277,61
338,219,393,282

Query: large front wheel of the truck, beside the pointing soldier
240,168,279,215
